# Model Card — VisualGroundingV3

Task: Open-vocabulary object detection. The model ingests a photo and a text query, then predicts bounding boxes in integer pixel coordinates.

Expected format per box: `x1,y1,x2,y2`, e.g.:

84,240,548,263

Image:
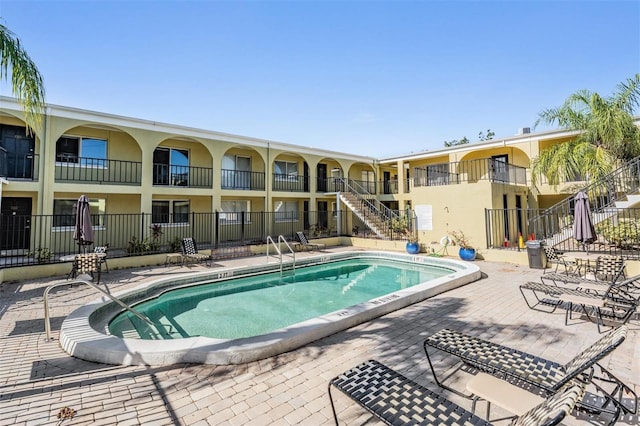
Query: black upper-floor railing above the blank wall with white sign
413,158,527,187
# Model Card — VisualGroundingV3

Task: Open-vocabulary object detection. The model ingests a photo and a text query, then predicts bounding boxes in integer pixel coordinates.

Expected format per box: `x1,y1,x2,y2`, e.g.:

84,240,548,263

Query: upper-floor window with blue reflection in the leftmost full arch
56,135,107,167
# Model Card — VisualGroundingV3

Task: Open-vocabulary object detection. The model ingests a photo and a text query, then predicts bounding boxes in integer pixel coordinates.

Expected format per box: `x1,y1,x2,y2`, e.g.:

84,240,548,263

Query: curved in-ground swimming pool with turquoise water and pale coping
60,252,480,365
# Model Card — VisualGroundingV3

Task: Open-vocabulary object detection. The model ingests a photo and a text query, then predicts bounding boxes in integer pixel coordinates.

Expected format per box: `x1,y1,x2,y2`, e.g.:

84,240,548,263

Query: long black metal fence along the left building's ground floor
0,210,403,267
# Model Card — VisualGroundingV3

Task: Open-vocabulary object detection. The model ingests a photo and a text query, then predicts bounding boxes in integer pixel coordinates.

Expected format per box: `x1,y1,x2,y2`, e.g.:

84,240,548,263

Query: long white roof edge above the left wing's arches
0,96,376,163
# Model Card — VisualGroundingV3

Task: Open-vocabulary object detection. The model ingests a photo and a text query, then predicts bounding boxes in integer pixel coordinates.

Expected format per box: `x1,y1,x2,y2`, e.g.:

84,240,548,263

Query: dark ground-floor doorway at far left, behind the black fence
0,197,31,254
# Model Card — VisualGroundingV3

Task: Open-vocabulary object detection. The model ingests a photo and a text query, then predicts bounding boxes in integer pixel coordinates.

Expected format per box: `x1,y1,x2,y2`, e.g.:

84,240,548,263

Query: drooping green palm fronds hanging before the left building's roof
0,24,44,132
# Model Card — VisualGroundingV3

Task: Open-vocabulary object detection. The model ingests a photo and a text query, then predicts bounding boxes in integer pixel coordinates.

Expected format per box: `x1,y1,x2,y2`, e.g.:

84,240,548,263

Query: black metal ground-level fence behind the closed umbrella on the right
485,208,640,259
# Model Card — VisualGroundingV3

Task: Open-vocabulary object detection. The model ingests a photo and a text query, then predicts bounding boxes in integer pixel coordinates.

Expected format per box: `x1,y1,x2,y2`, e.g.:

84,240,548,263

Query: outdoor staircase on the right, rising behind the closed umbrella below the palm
530,157,640,246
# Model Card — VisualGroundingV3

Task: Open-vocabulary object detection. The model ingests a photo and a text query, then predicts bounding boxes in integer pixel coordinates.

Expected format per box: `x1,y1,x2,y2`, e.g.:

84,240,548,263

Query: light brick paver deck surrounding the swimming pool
0,251,640,425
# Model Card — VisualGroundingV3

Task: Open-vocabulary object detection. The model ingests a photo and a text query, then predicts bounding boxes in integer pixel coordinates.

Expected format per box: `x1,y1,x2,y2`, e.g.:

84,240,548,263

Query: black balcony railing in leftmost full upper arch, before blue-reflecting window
55,156,142,185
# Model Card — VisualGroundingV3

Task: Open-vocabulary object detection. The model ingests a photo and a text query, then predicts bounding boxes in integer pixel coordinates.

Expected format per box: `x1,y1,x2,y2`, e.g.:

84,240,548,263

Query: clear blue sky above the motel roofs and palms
0,0,640,158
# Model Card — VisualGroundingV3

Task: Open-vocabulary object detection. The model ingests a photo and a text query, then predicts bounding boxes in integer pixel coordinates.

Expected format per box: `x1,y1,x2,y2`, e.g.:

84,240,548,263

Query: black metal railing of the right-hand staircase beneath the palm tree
530,157,640,243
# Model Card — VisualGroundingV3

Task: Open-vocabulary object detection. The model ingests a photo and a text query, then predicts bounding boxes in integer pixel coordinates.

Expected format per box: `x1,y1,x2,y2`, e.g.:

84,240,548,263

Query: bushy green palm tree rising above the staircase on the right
532,74,640,185
